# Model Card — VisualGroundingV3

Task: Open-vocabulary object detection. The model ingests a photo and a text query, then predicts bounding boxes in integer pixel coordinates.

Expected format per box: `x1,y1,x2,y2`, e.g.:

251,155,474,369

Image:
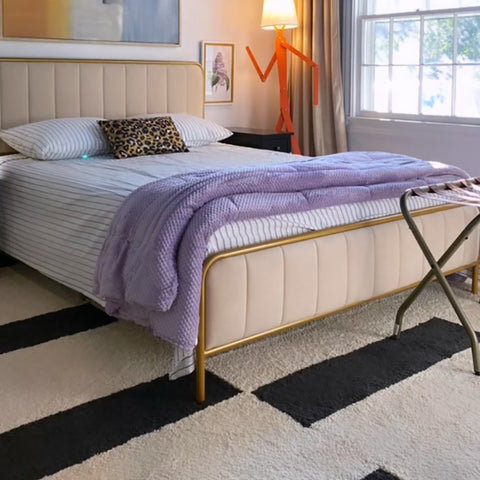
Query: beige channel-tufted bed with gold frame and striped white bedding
0,59,479,402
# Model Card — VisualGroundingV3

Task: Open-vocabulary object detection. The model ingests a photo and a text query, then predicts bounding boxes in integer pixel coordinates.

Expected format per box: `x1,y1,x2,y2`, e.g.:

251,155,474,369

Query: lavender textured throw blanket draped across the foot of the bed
95,152,467,348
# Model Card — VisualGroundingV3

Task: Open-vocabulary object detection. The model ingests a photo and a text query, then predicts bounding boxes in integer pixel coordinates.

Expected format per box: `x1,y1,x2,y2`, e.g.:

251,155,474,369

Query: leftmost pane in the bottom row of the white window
360,67,390,112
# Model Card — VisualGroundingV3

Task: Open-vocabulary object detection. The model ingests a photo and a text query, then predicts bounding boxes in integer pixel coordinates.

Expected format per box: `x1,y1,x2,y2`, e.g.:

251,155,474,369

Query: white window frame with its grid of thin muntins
350,0,480,125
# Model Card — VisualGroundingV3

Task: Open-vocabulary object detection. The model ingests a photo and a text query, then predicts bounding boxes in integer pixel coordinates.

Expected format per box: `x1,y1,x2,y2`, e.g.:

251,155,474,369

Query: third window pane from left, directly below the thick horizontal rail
423,17,453,64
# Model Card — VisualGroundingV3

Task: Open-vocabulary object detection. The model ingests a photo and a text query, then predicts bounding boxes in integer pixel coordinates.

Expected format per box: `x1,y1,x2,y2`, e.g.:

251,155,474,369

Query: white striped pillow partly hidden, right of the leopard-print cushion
128,113,233,147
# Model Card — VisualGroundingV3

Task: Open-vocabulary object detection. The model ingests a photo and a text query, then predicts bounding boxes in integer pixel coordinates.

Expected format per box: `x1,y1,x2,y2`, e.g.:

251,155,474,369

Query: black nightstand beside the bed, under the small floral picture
222,127,292,153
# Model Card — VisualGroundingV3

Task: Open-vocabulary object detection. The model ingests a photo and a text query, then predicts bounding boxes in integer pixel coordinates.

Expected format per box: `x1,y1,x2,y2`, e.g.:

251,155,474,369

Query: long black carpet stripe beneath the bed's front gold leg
0,372,238,480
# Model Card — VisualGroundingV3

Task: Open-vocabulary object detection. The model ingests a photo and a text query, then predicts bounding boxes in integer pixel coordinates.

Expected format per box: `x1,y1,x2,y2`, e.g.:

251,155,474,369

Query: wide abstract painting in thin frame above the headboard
2,0,180,46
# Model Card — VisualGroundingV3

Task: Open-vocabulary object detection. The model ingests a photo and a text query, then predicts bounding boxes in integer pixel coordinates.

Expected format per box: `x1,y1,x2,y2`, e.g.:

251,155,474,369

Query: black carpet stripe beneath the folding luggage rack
254,318,473,427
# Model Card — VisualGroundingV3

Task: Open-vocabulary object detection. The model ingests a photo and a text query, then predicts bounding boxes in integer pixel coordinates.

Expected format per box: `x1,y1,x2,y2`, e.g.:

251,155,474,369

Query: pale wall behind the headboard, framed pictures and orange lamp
0,0,278,129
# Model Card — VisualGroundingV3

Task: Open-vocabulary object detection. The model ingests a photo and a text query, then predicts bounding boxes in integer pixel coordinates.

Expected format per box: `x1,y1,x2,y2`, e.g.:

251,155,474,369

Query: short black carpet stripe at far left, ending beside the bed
0,303,116,354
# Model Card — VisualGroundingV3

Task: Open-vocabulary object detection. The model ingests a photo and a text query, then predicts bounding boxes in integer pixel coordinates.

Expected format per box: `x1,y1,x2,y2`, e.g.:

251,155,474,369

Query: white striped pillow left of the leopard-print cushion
0,117,111,160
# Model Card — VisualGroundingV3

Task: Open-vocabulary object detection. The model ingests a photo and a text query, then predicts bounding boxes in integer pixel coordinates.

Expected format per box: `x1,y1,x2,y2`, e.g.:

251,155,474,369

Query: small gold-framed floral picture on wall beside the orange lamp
203,42,235,103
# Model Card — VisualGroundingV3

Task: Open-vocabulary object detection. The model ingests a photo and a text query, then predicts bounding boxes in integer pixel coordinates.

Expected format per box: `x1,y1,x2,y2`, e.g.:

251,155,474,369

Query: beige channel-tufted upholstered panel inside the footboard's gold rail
205,207,479,350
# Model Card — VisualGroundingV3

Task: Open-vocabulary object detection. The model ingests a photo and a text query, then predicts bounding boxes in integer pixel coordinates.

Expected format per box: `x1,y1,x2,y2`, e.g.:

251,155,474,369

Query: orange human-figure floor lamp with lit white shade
247,0,319,154
